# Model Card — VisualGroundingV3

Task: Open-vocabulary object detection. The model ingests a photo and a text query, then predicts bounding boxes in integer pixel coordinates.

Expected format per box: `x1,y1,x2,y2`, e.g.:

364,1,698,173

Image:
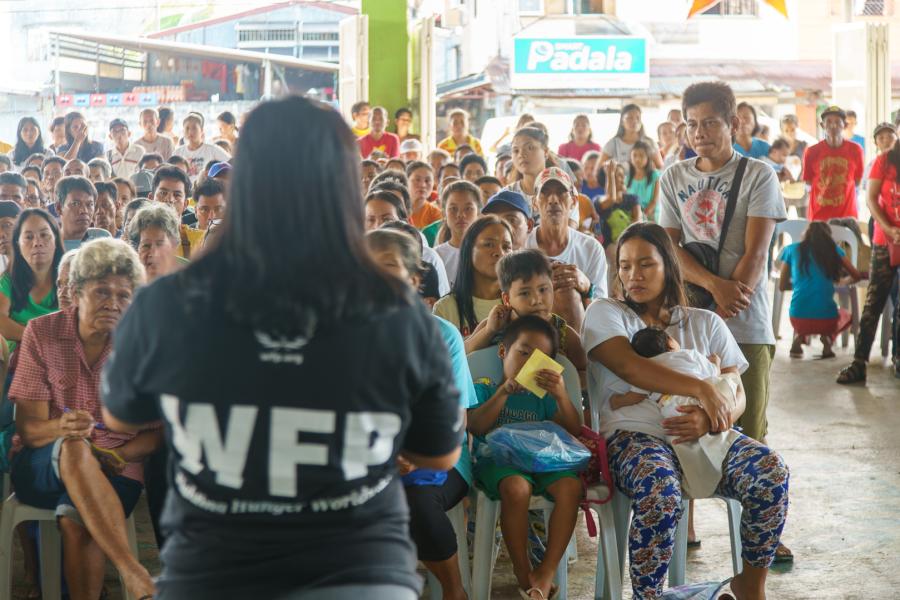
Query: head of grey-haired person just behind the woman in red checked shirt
128,202,188,281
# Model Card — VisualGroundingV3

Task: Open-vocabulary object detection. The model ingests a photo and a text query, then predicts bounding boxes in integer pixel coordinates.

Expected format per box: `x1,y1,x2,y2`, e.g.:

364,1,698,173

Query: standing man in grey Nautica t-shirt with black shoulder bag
660,82,787,441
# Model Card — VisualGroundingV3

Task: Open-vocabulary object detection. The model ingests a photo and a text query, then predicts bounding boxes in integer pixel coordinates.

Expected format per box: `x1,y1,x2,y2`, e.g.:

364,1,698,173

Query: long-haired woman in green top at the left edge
0,208,64,350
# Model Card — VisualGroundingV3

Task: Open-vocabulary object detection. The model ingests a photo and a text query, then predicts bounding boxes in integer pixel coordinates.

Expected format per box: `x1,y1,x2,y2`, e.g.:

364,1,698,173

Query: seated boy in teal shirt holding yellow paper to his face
468,315,582,598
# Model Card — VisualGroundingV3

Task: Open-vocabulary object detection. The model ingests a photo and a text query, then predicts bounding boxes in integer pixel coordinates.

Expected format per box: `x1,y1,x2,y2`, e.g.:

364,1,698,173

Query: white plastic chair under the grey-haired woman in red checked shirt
0,494,138,600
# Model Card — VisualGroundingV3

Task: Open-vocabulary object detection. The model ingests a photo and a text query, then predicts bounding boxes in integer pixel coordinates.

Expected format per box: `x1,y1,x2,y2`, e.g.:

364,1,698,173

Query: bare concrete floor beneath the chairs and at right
7,311,900,600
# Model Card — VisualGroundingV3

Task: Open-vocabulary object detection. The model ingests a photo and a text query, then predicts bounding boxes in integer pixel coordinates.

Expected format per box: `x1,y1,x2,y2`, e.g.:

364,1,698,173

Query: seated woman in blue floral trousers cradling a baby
583,223,789,600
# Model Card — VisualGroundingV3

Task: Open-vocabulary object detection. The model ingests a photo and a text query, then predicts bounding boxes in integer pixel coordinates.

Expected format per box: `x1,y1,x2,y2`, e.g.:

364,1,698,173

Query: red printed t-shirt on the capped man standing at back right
803,140,864,221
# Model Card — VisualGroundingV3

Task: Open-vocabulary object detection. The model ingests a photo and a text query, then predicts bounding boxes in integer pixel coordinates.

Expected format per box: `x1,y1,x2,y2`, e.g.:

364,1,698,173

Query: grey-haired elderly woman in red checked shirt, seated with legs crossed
9,239,161,600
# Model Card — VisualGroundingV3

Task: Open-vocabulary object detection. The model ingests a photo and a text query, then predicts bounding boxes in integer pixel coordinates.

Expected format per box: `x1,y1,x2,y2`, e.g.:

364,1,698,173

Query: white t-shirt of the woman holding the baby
581,299,749,439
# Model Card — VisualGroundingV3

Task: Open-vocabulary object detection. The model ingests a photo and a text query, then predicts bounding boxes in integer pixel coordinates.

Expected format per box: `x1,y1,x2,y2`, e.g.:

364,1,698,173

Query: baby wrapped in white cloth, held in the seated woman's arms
610,327,741,498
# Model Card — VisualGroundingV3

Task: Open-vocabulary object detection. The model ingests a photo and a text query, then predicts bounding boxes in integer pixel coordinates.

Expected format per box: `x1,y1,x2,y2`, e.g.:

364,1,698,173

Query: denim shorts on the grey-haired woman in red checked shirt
11,438,144,525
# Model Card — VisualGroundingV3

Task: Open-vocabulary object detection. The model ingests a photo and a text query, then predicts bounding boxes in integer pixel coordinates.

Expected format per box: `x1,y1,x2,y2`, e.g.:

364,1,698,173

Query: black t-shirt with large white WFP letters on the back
102,274,462,598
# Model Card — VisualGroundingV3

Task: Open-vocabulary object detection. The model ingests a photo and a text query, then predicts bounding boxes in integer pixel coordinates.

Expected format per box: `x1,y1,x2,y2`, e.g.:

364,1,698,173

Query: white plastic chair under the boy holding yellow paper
468,346,581,600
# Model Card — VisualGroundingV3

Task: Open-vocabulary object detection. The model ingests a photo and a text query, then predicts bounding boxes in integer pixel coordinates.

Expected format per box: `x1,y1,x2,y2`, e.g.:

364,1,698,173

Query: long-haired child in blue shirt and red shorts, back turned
779,221,862,358
